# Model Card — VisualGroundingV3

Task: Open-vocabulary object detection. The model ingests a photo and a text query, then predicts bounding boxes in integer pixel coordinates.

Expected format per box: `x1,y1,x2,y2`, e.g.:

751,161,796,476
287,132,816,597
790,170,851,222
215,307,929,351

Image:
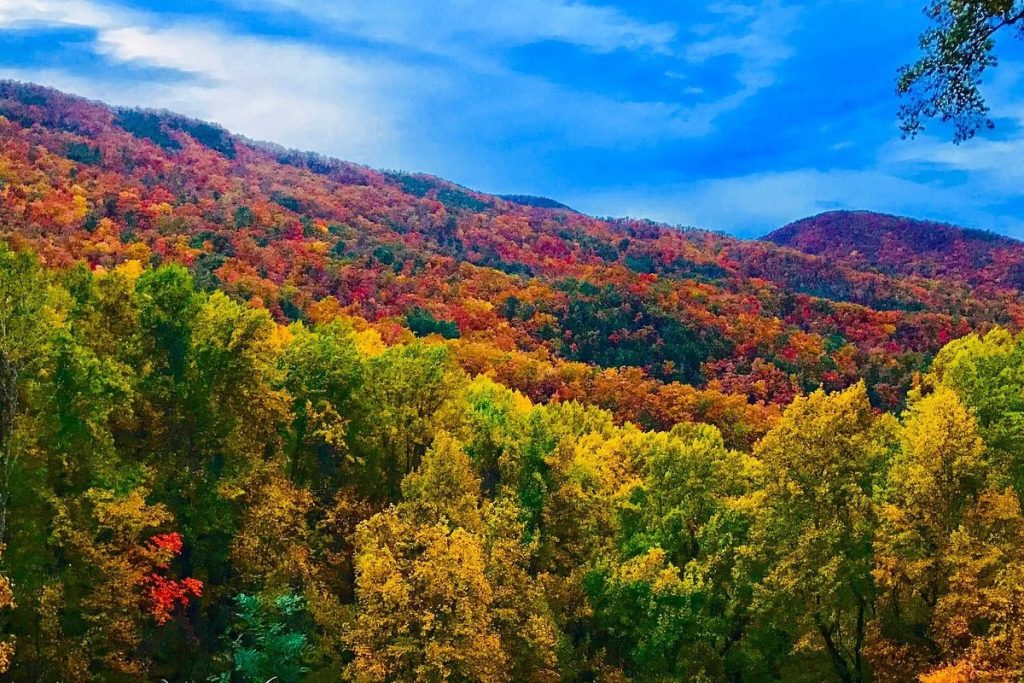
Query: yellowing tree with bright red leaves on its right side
41,488,203,680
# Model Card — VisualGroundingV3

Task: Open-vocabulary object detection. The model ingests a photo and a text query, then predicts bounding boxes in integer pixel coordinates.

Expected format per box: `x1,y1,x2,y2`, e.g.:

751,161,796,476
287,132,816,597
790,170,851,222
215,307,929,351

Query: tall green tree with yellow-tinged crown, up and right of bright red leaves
165,292,289,581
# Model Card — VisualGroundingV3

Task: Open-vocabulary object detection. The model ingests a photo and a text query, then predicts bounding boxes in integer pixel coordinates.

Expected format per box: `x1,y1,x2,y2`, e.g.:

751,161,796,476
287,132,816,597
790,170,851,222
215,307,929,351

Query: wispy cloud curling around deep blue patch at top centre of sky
231,0,799,146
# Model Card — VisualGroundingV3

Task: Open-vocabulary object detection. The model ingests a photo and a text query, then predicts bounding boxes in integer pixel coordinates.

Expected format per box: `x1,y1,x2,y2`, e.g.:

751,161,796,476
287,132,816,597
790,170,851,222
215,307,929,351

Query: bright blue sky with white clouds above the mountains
0,0,1024,237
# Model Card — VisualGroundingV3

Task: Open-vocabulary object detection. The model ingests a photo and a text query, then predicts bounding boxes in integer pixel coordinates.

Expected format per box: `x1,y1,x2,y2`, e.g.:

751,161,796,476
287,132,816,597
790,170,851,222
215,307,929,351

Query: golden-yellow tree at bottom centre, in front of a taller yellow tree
346,508,509,683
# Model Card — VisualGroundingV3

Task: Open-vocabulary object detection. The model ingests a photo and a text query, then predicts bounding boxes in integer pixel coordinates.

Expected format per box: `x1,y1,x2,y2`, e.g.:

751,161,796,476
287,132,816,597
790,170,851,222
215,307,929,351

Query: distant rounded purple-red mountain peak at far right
765,211,1024,289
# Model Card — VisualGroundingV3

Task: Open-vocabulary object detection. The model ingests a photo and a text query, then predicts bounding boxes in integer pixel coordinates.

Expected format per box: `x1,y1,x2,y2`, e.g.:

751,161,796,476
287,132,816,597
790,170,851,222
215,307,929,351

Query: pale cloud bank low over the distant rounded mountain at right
565,48,1024,239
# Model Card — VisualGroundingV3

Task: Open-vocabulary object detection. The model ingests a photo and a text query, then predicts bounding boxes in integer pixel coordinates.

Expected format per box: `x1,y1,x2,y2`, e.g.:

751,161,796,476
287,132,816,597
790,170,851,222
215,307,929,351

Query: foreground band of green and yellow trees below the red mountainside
0,242,1024,683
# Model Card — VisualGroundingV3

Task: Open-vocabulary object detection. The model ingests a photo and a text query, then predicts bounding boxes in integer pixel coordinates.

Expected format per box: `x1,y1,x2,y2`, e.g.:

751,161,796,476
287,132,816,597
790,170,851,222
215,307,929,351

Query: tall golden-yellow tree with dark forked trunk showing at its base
751,383,890,683
